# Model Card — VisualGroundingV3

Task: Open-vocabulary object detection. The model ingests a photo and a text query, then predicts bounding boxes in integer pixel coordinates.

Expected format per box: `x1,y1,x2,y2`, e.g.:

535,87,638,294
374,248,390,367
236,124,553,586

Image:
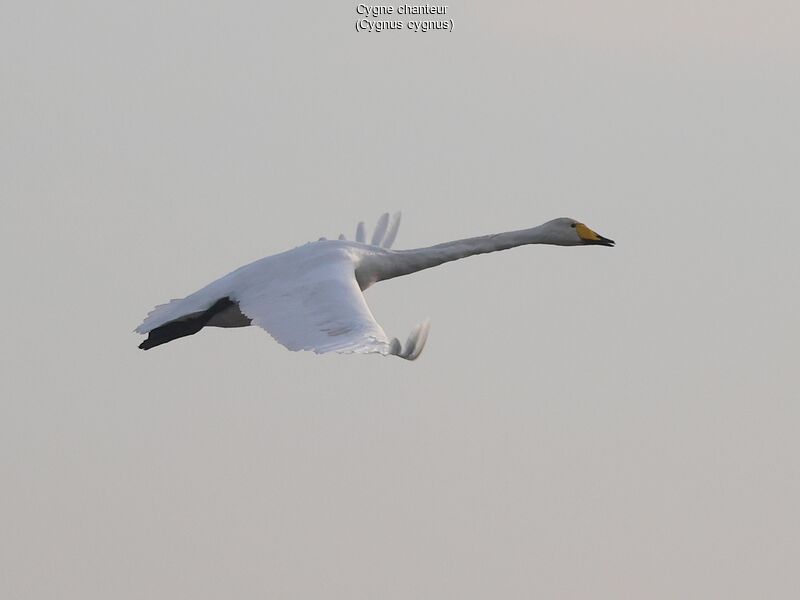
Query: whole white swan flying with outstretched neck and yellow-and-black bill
136,213,614,360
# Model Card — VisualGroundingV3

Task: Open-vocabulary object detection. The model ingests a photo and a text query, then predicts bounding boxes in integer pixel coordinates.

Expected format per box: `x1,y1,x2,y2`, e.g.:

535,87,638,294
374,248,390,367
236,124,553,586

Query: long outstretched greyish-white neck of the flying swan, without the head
357,225,548,287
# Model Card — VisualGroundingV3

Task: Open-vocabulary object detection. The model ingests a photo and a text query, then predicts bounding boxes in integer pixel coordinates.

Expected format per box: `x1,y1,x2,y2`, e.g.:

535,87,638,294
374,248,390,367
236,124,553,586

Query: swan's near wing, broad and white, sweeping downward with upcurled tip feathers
237,261,424,360
